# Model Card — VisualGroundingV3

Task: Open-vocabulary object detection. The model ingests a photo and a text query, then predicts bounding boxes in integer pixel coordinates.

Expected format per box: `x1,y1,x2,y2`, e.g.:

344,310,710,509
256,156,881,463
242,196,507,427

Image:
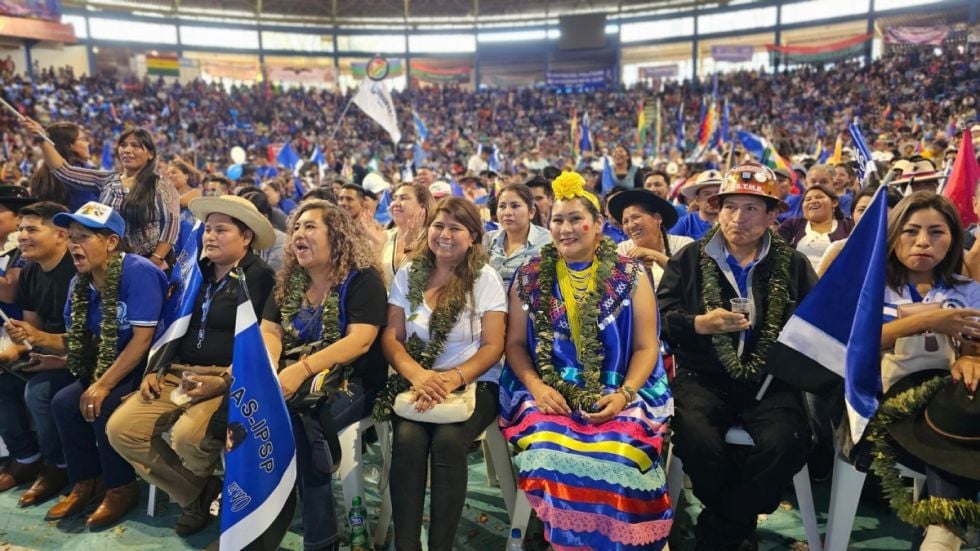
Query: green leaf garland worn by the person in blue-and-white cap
66,254,123,382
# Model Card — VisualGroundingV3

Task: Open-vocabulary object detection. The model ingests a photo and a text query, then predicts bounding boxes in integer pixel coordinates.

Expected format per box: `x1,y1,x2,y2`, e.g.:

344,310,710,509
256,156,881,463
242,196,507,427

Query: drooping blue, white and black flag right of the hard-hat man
769,186,888,442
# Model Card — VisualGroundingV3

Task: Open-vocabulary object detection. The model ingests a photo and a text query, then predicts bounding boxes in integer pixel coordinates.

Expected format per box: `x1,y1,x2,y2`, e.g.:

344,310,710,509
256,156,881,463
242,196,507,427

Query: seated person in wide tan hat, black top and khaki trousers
106,195,275,536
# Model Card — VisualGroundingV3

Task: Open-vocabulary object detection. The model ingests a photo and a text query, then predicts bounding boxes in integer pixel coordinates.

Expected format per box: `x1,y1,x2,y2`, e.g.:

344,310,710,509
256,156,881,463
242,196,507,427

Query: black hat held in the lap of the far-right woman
883,372,980,480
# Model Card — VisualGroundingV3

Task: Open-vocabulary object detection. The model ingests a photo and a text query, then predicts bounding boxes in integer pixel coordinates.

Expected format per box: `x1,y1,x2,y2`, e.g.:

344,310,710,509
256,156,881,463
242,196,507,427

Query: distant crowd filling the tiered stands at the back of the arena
0,44,980,188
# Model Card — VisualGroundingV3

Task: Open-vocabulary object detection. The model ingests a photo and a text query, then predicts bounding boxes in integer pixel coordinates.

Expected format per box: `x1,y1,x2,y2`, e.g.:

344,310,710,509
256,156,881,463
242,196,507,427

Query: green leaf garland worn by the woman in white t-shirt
374,255,470,421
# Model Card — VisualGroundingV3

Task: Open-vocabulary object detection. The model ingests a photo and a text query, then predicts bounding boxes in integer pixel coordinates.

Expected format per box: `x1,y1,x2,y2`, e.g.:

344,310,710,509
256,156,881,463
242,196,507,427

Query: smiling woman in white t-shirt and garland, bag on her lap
375,197,507,551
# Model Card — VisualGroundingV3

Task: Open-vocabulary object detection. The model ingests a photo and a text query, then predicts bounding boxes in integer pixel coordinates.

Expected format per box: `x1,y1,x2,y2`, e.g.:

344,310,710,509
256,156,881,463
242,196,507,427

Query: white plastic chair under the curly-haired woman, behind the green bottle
337,417,391,545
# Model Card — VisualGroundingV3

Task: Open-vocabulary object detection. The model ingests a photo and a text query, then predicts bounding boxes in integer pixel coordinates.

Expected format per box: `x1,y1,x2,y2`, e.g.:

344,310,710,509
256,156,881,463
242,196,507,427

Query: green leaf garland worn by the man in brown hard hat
699,226,792,381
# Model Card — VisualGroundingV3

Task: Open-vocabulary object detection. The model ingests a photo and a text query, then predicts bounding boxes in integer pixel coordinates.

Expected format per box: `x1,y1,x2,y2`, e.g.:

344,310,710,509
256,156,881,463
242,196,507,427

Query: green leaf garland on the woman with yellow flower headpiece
534,238,617,413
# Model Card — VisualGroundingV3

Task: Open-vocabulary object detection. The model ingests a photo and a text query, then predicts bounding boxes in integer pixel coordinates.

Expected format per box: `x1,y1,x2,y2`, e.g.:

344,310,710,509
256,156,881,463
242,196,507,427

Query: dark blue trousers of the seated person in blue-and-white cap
51,369,142,488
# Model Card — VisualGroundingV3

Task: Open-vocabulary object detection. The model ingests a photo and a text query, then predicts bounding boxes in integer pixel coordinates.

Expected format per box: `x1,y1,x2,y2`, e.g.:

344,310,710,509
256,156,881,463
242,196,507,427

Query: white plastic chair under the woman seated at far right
826,455,926,551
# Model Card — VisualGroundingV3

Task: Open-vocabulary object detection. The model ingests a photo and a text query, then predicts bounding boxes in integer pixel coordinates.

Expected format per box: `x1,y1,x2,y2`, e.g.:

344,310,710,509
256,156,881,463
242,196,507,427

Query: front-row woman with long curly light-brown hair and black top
261,200,388,549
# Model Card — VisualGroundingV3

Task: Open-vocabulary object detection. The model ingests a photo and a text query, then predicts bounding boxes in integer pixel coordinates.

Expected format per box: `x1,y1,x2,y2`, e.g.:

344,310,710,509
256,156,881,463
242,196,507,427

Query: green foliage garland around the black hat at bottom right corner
868,376,980,528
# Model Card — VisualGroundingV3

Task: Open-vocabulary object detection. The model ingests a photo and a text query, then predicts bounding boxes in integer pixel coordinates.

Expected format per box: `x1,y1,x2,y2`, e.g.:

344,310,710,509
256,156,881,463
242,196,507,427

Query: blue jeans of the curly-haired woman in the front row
290,379,374,549
